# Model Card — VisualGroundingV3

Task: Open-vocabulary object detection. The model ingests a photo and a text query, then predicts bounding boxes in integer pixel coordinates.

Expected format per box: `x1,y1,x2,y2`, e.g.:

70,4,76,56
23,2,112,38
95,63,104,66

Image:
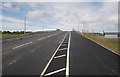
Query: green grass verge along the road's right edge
77,32,120,54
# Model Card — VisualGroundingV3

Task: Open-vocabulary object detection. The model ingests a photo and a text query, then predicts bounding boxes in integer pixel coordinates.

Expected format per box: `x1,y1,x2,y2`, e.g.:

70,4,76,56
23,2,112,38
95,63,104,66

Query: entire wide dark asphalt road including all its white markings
2,31,120,77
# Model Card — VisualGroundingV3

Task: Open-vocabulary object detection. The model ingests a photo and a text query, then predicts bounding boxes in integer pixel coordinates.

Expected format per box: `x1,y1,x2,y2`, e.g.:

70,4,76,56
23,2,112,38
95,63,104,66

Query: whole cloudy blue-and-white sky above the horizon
0,2,118,32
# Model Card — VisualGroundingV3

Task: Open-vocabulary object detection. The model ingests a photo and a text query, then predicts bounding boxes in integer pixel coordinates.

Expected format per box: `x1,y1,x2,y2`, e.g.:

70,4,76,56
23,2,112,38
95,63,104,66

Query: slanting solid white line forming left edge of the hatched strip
40,33,68,77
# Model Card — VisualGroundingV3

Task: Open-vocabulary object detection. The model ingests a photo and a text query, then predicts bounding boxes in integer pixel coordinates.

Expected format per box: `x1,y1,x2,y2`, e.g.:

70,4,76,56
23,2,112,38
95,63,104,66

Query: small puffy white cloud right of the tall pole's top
27,10,44,19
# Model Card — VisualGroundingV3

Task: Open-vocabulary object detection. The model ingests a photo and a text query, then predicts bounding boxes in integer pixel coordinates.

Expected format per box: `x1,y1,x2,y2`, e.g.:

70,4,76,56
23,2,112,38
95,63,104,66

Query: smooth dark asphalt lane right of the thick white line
69,32,120,75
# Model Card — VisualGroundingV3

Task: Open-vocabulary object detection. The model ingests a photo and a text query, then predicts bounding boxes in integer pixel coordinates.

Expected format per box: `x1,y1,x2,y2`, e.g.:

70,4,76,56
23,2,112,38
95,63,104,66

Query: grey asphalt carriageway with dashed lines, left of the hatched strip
2,31,67,75
